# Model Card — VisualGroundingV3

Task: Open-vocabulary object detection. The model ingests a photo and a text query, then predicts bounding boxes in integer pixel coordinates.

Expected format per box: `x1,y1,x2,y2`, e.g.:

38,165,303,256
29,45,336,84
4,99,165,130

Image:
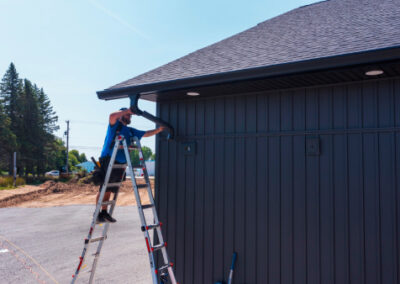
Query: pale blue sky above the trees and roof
0,0,318,158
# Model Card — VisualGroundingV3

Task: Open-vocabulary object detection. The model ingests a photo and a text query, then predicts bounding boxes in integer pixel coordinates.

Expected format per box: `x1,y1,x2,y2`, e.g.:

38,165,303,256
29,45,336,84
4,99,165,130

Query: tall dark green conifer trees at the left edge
0,63,86,176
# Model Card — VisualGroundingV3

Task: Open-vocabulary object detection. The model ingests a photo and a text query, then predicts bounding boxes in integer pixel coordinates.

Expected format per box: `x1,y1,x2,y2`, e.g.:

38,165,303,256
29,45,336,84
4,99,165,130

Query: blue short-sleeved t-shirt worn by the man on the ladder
101,120,146,164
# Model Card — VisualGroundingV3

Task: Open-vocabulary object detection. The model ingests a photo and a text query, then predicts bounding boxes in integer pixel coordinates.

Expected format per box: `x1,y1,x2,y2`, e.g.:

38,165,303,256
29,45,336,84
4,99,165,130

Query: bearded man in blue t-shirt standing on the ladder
96,108,164,223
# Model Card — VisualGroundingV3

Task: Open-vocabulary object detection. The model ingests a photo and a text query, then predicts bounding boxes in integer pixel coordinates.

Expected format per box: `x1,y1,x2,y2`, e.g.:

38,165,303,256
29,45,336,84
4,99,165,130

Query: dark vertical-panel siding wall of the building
156,78,400,284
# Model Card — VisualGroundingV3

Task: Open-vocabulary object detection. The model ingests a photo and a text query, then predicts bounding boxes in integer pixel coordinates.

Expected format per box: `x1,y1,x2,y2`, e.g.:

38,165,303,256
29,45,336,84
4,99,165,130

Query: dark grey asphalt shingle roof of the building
104,0,400,90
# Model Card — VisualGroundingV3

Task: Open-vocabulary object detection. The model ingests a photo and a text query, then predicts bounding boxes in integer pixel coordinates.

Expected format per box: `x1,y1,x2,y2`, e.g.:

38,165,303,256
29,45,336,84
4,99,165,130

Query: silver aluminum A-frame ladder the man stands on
71,135,176,284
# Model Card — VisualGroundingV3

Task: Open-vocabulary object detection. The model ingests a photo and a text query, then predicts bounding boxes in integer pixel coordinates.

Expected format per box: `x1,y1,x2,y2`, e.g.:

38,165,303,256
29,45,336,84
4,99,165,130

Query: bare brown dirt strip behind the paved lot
0,180,154,208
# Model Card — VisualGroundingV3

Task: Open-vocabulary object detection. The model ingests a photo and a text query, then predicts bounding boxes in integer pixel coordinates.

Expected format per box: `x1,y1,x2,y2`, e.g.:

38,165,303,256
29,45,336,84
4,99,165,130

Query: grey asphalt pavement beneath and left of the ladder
0,205,151,284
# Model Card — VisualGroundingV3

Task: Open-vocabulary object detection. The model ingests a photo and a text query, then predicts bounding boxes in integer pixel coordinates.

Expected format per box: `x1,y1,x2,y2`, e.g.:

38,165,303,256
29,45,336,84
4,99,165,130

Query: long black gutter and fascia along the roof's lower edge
97,46,400,100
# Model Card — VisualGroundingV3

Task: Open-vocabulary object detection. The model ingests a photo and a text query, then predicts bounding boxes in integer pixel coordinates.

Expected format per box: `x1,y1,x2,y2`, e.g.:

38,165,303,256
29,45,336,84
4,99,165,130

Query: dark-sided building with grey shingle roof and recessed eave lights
98,0,400,284
